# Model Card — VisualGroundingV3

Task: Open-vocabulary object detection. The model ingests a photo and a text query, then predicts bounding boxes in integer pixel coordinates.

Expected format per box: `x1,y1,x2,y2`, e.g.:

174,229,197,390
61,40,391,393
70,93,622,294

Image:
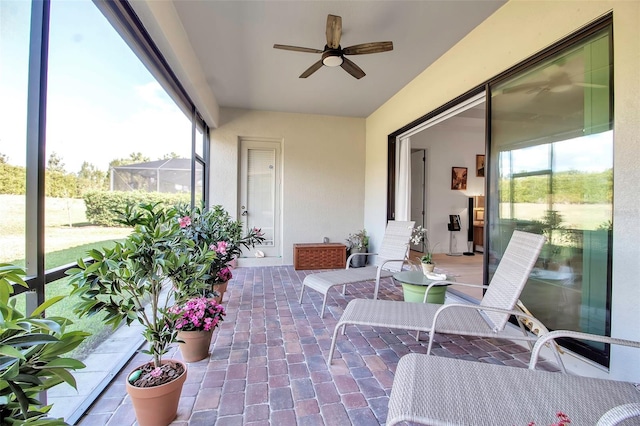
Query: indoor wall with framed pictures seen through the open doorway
411,125,484,253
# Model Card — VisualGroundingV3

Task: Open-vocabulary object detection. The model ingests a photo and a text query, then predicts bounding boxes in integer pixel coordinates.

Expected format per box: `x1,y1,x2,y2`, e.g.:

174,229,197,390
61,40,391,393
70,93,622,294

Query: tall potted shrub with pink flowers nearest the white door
179,205,264,301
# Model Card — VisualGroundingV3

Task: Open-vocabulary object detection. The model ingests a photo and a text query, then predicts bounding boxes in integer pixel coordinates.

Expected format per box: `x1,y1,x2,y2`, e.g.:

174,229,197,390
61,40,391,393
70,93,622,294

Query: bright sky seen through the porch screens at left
0,0,191,172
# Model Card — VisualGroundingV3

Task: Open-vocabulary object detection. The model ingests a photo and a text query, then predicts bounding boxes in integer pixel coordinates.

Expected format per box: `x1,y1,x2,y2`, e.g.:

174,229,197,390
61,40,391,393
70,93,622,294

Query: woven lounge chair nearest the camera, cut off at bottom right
387,330,640,426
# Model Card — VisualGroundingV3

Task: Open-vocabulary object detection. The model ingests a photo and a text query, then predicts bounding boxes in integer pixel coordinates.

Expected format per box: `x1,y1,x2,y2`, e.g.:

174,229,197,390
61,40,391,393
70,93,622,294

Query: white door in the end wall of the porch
240,139,282,257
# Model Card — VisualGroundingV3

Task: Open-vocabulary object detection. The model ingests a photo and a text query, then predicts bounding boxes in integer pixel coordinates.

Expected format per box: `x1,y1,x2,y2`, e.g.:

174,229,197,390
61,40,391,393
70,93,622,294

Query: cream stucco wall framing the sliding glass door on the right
364,0,640,381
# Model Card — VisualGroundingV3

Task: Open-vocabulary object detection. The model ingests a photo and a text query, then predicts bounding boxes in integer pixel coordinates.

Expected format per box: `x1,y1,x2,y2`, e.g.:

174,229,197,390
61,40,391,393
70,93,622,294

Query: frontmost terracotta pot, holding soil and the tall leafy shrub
126,359,187,426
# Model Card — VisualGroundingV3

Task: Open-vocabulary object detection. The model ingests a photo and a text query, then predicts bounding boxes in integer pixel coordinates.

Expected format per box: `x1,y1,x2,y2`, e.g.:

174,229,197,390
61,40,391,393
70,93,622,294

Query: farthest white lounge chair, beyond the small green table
300,221,415,317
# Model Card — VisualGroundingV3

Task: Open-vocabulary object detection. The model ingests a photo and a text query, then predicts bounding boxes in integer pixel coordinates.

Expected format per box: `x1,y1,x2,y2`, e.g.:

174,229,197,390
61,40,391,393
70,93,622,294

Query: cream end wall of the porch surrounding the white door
210,108,365,265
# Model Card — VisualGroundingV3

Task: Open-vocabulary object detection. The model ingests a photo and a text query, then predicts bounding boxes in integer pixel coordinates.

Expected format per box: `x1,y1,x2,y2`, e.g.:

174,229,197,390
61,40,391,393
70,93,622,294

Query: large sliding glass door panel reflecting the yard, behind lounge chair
487,22,613,364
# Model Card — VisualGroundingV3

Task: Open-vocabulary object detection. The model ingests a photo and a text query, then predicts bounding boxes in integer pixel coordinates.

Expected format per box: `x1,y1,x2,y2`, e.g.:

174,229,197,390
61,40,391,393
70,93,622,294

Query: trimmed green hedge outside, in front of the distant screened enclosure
84,191,191,226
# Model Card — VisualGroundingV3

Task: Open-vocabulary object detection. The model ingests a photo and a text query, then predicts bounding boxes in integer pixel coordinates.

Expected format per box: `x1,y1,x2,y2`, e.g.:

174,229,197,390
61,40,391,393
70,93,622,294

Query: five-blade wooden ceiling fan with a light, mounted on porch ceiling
273,15,393,79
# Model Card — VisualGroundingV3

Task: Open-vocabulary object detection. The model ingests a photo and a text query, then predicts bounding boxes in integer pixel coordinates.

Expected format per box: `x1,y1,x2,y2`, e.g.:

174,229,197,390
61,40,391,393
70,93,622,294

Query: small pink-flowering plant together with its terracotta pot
169,297,225,362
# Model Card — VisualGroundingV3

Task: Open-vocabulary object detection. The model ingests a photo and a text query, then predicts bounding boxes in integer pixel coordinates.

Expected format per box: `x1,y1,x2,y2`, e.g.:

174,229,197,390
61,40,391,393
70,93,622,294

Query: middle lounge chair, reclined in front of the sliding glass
328,231,547,364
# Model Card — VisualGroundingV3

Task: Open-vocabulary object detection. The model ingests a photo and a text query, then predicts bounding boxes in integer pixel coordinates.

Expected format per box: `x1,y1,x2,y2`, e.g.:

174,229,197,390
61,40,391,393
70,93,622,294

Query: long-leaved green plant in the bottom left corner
0,263,89,426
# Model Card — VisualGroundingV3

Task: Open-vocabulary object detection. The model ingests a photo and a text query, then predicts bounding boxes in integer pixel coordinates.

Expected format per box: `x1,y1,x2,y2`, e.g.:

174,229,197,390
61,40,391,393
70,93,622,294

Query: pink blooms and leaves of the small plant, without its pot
169,297,225,331
